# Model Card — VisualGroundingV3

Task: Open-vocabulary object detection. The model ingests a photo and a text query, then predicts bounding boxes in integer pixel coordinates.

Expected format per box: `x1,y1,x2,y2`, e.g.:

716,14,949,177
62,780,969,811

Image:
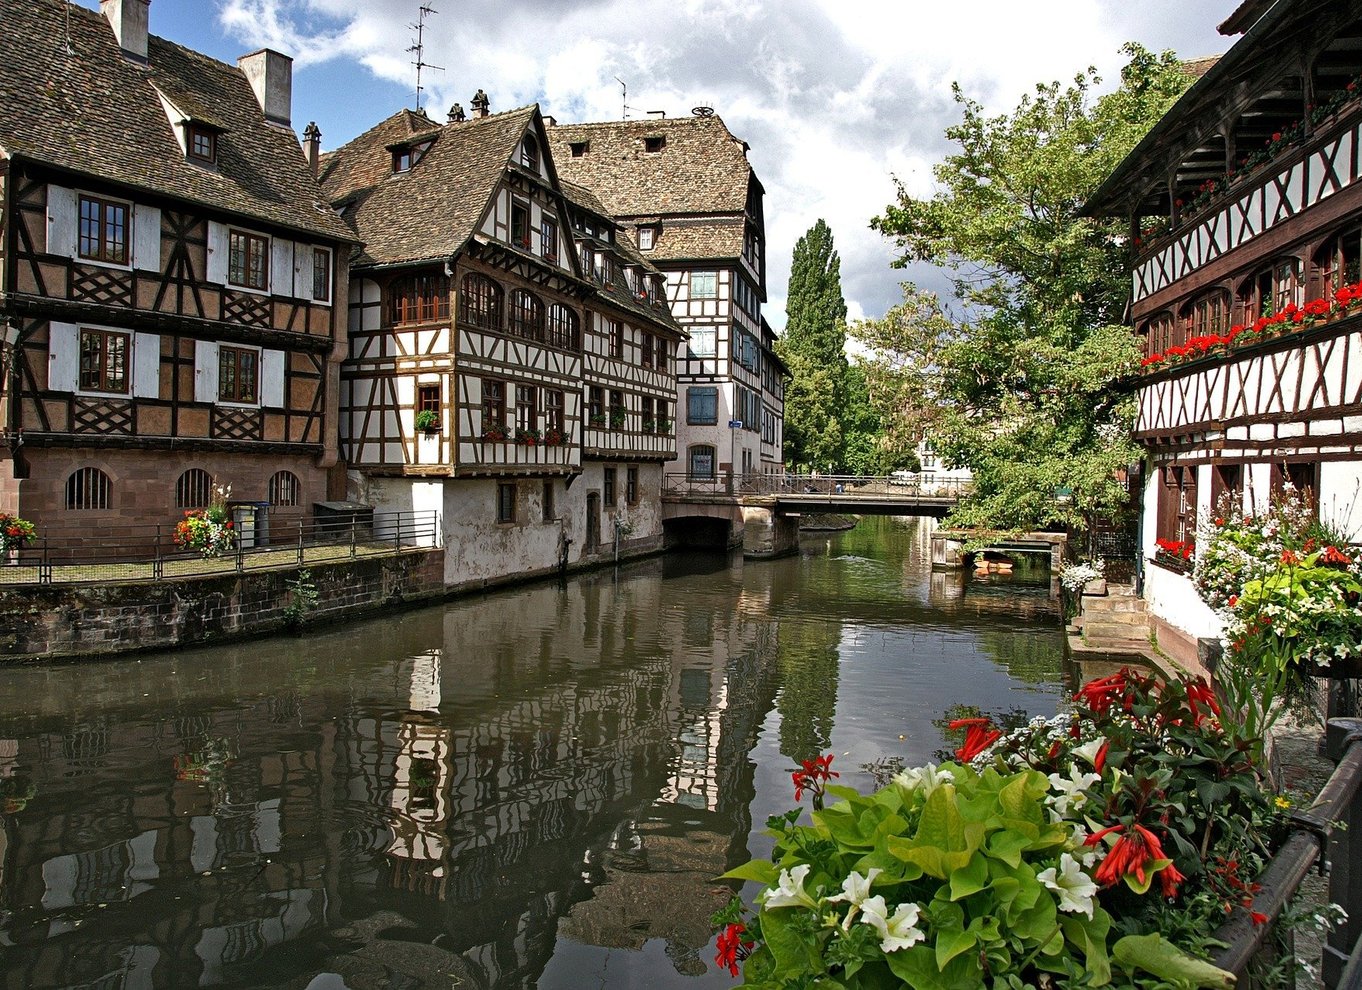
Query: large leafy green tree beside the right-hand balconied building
853,45,1188,530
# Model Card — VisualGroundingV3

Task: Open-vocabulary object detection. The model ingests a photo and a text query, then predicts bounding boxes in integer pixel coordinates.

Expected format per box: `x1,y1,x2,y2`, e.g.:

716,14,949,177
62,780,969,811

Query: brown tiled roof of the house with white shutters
0,0,353,240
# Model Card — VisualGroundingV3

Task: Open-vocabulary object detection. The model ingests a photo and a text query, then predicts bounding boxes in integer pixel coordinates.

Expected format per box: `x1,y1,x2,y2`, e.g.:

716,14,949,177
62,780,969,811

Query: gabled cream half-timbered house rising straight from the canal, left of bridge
321,91,681,586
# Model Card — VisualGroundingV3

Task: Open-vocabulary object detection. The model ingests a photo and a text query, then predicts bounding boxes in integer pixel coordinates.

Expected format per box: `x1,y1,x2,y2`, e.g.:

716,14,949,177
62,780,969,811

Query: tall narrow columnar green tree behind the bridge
778,219,847,470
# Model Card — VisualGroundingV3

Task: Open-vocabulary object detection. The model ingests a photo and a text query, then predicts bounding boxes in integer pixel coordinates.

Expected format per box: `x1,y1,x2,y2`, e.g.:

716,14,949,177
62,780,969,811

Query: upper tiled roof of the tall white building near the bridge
548,117,756,217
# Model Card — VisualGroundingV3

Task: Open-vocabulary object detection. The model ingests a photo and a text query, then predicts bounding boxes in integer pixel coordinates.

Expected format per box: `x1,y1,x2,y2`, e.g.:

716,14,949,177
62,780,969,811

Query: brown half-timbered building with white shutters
0,0,354,542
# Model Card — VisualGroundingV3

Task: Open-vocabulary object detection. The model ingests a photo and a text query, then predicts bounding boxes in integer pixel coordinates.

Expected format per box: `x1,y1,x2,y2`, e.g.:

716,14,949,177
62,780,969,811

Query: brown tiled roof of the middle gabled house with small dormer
321,106,537,264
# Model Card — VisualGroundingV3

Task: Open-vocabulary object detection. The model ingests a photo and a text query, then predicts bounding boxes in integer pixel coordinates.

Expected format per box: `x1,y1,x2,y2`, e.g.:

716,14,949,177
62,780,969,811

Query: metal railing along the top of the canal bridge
662,471,972,500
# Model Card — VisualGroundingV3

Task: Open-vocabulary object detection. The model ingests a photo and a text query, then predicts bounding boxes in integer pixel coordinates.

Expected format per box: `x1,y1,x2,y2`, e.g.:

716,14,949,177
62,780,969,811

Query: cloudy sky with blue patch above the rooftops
78,0,1238,330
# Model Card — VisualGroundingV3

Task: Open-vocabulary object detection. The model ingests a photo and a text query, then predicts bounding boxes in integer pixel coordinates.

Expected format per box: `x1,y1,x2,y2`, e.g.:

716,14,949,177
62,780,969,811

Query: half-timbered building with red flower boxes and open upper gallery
1087,0,1362,659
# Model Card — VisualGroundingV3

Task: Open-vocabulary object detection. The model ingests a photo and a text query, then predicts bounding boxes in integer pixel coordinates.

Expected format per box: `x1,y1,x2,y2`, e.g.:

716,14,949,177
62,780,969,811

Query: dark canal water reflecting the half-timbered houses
0,519,1064,990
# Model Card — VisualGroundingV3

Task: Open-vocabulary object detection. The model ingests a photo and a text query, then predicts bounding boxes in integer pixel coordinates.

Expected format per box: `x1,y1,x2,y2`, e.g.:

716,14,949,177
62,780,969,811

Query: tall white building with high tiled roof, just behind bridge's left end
549,112,783,487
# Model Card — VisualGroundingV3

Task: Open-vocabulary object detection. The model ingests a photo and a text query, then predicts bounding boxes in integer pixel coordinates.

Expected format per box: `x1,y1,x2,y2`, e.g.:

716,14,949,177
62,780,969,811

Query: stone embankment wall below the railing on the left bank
0,549,445,659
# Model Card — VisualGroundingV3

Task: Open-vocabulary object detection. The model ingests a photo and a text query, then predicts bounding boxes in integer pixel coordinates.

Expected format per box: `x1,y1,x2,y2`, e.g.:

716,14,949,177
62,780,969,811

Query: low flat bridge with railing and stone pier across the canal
662,473,970,557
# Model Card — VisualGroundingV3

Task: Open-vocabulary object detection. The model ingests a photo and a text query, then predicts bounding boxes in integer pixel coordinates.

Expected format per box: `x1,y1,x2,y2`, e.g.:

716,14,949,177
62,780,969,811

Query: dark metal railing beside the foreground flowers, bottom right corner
1212,719,1362,990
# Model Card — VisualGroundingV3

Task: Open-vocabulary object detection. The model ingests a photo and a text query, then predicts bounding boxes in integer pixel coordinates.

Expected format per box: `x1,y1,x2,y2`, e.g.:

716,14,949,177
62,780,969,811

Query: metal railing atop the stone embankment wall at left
0,511,441,587
